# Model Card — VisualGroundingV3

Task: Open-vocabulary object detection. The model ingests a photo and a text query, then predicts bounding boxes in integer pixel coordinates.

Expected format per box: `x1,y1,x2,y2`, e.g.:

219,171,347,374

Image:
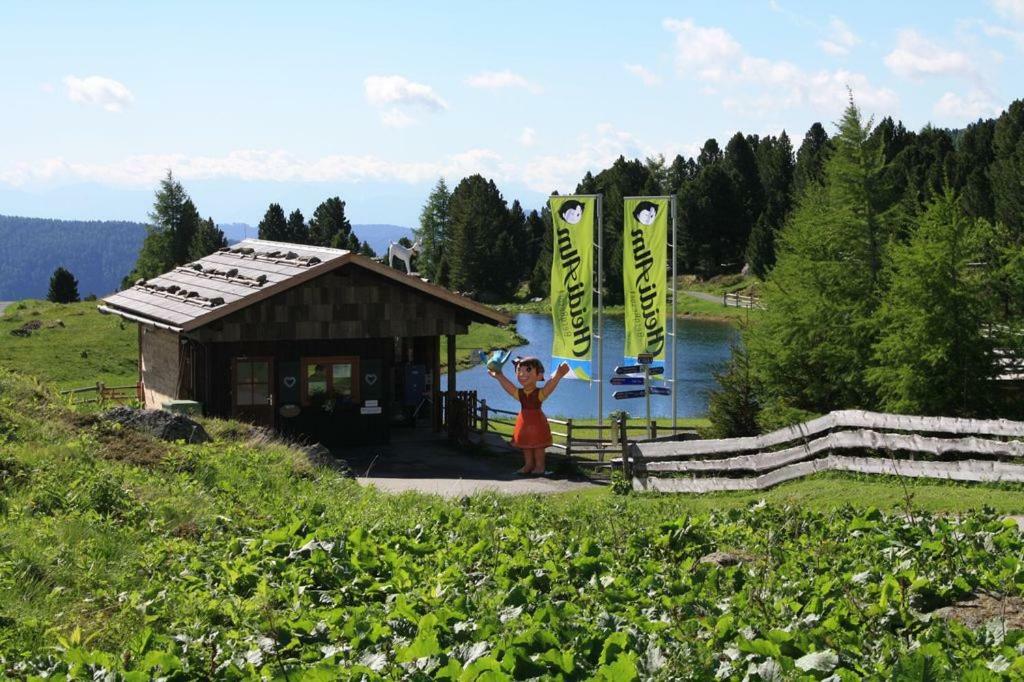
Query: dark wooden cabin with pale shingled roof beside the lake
99,240,510,445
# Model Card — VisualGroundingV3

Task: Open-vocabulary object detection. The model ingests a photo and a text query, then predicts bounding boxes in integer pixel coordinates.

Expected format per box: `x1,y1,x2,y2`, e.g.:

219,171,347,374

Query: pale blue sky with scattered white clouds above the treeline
0,0,1024,225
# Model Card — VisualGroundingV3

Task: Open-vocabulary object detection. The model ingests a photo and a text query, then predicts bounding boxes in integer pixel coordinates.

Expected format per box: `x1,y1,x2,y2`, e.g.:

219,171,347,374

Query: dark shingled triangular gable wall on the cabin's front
188,266,469,342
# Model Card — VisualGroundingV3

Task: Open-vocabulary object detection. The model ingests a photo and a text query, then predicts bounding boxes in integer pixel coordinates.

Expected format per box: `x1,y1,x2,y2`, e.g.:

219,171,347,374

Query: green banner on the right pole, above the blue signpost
623,197,670,365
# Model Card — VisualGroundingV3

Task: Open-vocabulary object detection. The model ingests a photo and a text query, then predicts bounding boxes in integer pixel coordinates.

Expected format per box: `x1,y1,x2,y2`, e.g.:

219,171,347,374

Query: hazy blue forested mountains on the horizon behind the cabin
0,215,413,301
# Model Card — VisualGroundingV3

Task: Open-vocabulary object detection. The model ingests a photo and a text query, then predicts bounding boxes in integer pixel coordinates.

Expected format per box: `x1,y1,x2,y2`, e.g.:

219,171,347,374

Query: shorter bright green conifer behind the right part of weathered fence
867,190,996,417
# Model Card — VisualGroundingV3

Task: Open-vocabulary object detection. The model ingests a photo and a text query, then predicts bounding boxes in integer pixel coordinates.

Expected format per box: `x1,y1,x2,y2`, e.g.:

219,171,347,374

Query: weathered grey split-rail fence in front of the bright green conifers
621,410,1024,493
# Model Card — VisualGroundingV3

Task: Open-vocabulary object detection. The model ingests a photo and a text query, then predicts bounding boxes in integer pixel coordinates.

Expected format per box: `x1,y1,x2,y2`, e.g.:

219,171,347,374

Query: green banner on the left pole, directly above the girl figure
548,197,596,380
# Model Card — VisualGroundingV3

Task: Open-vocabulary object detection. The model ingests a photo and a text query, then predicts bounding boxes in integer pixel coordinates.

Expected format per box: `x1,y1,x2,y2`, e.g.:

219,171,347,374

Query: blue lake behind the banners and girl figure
441,313,739,419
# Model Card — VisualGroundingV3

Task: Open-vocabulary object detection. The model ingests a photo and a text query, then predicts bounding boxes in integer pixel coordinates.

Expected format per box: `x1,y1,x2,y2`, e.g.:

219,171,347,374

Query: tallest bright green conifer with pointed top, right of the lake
745,101,890,412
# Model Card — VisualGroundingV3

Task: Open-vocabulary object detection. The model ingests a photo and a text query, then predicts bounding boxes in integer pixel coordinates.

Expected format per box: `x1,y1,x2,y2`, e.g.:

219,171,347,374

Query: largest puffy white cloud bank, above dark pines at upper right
663,19,898,115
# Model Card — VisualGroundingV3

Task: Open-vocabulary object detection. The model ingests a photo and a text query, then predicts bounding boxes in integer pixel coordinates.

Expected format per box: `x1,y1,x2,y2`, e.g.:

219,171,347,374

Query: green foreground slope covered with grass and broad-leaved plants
0,371,1024,680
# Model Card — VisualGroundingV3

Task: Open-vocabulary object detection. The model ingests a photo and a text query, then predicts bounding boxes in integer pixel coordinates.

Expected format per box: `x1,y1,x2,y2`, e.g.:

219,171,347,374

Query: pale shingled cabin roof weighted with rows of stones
98,240,511,332
